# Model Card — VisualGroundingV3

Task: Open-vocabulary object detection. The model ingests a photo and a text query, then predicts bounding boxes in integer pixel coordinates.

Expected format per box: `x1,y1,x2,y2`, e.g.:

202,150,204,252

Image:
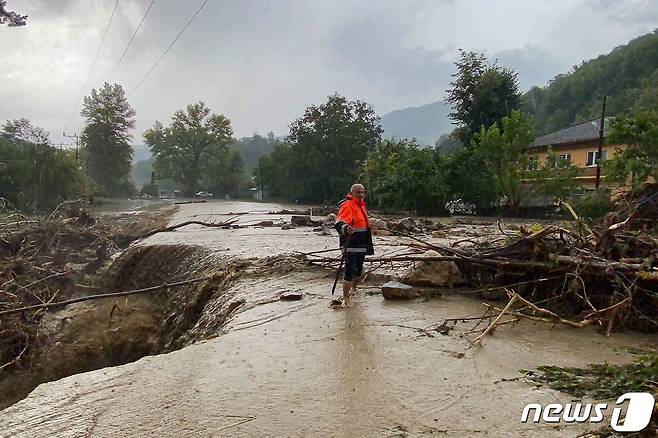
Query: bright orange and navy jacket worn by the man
335,194,375,255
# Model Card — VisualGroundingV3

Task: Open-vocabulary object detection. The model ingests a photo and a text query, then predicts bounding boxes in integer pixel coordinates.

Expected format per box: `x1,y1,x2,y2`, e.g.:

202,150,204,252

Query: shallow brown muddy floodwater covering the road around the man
0,201,656,437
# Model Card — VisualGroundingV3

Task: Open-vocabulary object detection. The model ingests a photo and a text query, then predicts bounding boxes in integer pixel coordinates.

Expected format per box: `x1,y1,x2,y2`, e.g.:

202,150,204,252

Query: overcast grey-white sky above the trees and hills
0,0,658,143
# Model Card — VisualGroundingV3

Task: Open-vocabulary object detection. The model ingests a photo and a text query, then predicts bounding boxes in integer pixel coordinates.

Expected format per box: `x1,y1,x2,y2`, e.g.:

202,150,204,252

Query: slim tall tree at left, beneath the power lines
81,82,135,196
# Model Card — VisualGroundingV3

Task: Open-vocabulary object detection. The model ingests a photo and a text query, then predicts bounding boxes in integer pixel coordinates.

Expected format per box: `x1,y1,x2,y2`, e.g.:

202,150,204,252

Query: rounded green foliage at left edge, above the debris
0,119,83,212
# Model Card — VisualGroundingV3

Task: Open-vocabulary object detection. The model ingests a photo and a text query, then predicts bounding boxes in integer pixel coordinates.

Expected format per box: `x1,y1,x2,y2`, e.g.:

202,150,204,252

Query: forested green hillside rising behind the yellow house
523,29,658,135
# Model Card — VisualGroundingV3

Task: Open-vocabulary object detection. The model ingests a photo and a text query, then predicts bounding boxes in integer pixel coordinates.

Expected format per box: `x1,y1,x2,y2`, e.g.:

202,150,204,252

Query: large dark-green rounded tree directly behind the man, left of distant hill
288,94,383,202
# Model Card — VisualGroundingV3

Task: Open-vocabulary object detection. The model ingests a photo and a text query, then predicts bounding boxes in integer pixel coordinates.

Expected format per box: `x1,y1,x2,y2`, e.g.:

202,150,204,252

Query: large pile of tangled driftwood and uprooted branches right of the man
305,189,658,341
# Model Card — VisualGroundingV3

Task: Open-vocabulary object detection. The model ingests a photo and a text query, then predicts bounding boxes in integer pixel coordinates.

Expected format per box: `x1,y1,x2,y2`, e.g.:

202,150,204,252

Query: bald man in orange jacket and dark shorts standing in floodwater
335,184,375,305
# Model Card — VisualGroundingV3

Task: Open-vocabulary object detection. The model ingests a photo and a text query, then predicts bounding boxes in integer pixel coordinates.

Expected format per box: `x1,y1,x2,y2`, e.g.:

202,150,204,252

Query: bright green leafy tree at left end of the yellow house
472,110,534,214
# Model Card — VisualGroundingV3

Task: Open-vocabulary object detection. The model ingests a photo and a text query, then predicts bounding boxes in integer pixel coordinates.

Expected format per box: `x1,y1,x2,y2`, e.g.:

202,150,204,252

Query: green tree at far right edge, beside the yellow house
604,111,658,188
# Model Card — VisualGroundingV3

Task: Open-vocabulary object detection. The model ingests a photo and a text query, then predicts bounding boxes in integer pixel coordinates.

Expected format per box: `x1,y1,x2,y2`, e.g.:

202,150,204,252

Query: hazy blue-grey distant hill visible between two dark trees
381,101,454,145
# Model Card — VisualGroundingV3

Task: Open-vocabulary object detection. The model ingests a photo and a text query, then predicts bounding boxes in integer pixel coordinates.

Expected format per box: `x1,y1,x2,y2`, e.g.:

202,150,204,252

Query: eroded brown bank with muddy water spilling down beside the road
0,238,302,408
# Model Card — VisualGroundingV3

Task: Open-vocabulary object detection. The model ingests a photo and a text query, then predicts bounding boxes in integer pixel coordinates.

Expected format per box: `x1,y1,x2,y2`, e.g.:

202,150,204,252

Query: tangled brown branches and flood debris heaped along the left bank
0,202,173,372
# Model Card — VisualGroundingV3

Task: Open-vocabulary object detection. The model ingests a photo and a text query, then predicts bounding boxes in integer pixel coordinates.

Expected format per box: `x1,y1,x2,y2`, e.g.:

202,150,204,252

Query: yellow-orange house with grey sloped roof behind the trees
529,118,627,190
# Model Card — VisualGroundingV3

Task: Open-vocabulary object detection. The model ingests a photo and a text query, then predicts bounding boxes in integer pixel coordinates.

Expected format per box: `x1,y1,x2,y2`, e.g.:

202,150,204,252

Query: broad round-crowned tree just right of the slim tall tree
144,102,233,196
